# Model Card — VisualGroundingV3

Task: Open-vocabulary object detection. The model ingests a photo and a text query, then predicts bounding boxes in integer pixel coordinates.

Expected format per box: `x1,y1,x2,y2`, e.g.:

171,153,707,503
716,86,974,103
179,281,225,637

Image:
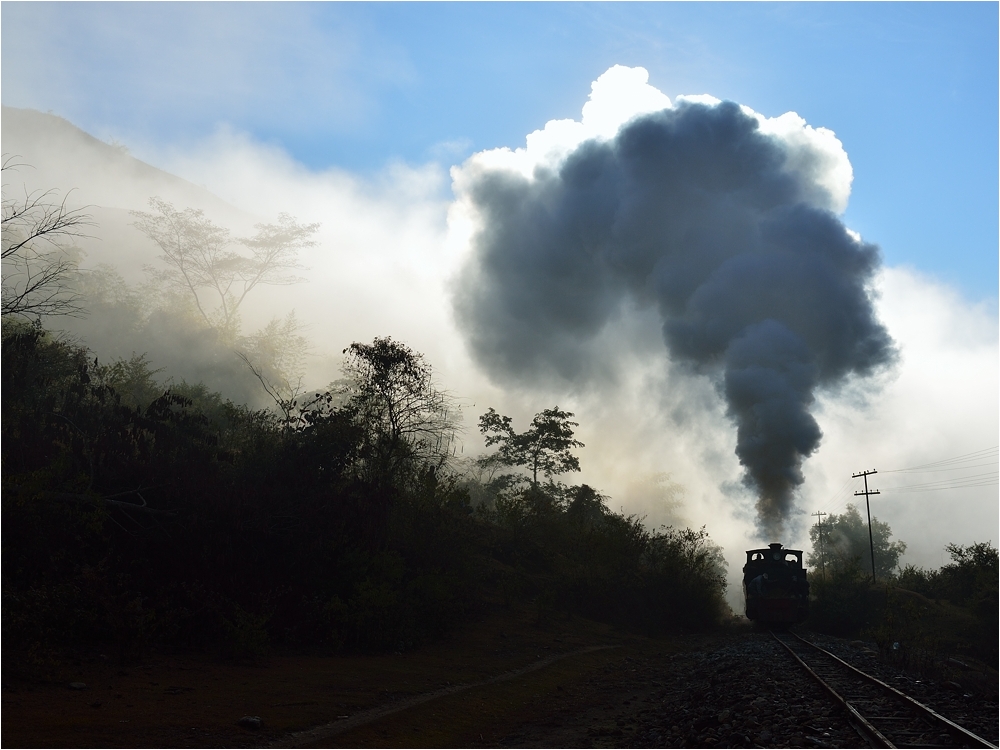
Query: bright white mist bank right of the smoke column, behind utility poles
801,268,1000,567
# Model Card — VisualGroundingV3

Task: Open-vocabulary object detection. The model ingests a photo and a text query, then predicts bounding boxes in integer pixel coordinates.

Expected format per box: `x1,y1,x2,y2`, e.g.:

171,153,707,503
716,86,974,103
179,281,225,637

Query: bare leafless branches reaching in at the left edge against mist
0,159,94,318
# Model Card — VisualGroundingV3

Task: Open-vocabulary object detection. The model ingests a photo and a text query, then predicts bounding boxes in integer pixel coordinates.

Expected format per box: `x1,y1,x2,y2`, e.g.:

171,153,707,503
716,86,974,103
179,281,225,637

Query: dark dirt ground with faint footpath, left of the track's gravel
2,611,732,747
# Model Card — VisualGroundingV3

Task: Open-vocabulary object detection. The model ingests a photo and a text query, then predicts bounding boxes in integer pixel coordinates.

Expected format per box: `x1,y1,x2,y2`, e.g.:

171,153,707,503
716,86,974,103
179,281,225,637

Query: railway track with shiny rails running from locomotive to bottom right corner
771,631,996,748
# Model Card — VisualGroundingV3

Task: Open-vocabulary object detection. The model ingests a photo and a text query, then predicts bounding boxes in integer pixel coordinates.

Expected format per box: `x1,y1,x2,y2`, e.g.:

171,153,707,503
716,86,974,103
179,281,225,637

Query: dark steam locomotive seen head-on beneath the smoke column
743,542,809,626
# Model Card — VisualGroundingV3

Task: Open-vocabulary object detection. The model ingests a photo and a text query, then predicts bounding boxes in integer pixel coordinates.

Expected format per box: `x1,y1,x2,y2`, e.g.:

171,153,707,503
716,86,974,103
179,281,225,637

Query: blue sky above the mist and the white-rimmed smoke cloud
0,2,998,300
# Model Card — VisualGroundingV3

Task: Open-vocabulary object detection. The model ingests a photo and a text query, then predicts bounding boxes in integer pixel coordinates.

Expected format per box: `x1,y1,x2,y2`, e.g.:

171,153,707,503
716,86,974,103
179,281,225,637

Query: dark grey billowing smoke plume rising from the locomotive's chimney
455,101,894,534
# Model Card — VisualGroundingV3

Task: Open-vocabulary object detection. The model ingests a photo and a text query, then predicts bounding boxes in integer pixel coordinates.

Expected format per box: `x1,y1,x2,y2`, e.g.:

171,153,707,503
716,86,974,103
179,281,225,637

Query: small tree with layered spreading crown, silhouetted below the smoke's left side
479,406,584,488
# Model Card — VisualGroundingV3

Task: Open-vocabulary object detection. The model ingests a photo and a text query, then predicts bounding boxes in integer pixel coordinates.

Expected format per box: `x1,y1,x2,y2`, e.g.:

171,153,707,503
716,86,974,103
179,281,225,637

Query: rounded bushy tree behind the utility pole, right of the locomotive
807,504,906,578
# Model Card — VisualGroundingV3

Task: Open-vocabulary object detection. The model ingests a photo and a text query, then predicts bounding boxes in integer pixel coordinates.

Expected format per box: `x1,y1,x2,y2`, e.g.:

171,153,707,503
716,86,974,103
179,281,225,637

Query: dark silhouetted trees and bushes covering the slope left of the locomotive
0,326,727,658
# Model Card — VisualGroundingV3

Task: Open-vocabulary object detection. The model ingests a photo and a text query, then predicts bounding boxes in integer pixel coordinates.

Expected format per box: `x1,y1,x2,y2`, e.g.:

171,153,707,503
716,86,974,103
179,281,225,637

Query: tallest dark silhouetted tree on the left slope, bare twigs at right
341,336,458,484
